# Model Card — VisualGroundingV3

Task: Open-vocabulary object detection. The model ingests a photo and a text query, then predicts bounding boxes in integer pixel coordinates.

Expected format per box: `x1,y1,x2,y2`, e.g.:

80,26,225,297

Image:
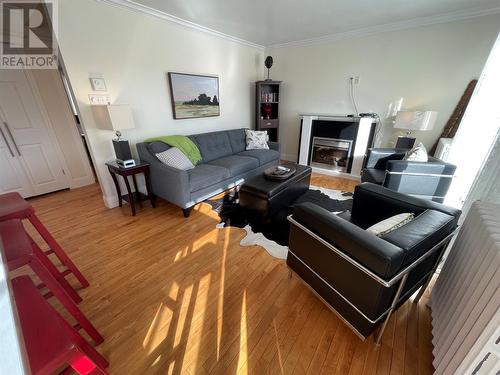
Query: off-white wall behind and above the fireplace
266,15,500,160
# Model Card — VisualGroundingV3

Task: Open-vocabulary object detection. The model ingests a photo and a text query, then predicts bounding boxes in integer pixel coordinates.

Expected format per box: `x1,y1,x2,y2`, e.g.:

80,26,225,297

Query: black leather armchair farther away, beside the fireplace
361,148,456,203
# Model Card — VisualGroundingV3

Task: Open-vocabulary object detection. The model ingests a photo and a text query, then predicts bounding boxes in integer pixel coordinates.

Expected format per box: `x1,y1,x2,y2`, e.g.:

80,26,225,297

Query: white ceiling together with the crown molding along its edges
97,0,500,49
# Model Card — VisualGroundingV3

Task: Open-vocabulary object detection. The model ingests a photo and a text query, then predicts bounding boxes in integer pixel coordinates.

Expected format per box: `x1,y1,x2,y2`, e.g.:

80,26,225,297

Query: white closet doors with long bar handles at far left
0,70,69,197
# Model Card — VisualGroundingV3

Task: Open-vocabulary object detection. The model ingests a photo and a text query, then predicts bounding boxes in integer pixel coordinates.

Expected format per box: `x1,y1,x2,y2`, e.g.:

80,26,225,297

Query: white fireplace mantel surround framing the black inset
299,113,374,179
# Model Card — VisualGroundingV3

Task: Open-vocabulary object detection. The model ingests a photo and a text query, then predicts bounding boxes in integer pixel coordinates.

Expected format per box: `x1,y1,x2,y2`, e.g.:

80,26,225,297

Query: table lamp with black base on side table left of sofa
92,104,135,167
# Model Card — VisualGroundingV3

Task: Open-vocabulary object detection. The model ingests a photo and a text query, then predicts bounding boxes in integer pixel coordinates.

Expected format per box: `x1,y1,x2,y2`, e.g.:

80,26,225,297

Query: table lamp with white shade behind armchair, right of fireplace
394,111,437,149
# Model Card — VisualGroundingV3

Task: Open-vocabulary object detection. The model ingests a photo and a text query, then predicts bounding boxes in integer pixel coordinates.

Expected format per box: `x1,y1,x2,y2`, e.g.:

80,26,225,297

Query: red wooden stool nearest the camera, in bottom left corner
12,276,108,375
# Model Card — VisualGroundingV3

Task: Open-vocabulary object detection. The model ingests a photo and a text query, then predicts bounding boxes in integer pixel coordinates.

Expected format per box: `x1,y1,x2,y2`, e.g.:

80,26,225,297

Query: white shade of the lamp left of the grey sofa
92,104,135,131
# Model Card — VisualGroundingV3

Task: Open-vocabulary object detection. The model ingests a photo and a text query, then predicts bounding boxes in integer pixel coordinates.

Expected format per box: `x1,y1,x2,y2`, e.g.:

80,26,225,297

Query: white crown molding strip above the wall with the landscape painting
96,0,265,50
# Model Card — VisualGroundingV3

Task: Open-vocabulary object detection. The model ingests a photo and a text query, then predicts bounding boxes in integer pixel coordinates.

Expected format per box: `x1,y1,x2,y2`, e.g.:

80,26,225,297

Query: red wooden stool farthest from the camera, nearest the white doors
0,193,89,288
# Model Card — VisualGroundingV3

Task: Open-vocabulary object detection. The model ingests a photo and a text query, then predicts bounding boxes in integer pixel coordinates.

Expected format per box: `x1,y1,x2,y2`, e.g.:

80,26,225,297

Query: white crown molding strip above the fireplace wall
266,7,500,48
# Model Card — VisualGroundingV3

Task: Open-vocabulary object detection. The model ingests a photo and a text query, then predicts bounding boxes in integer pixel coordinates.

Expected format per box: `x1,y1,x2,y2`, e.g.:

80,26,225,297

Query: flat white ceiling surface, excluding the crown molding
127,0,500,46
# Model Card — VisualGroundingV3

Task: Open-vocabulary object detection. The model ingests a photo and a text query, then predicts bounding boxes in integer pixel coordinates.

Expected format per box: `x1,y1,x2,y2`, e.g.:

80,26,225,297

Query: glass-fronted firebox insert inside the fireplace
309,137,352,173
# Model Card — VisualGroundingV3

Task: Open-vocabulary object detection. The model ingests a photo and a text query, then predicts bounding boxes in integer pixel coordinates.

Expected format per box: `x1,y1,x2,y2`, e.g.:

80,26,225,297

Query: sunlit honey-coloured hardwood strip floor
23,175,432,375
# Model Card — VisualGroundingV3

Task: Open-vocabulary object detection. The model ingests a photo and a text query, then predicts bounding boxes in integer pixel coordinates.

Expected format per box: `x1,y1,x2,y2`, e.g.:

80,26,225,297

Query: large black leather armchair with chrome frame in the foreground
287,183,461,343
